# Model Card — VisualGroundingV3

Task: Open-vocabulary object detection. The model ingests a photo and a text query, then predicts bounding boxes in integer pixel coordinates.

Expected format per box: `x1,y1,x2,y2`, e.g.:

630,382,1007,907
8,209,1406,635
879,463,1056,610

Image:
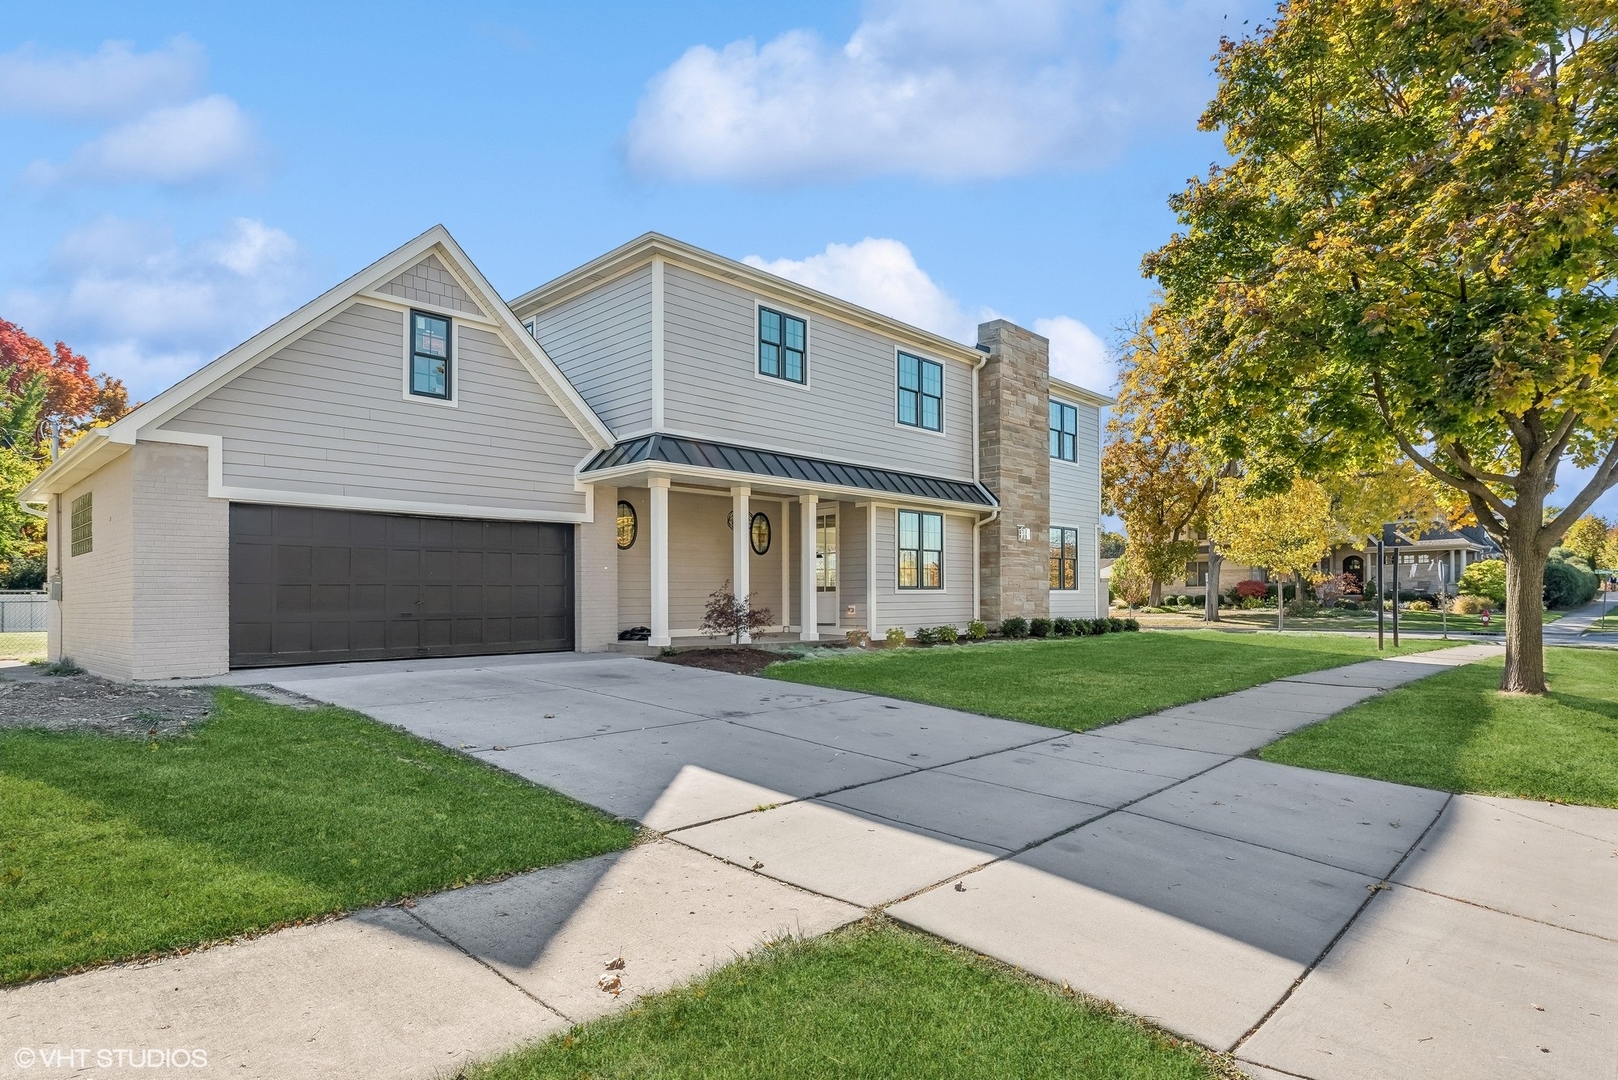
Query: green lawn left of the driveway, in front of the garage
0,691,633,984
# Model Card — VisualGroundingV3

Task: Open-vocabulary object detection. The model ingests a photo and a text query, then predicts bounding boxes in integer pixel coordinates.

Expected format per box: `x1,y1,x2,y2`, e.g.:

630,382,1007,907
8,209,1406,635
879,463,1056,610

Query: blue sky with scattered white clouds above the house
0,0,1613,524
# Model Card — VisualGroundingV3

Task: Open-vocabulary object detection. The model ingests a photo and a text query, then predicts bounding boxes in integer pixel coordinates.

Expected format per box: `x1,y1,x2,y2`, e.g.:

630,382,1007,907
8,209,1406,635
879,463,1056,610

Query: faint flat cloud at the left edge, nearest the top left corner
0,36,207,120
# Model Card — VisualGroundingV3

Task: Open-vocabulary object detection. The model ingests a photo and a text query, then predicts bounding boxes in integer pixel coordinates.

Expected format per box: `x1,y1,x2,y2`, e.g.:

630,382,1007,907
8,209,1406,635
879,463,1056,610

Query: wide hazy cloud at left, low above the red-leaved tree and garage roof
5,217,304,398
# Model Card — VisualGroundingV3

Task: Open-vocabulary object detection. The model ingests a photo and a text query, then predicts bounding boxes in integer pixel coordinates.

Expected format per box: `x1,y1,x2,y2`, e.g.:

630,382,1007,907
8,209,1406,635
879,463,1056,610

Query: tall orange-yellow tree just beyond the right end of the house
1102,319,1217,607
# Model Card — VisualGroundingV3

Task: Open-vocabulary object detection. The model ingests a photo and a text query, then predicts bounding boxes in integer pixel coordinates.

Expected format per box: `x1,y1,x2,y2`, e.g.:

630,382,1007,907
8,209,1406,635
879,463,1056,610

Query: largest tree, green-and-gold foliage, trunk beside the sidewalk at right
1146,0,1618,693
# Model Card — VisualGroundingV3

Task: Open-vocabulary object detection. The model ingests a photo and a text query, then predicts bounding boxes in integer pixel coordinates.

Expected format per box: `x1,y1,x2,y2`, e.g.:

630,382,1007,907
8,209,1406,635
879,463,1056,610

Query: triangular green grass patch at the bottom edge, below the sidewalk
461,925,1241,1080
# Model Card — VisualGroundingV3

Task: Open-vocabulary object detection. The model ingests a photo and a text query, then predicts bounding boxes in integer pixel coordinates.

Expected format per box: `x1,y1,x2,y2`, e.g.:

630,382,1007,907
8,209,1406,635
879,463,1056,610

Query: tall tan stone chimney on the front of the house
977,319,1050,625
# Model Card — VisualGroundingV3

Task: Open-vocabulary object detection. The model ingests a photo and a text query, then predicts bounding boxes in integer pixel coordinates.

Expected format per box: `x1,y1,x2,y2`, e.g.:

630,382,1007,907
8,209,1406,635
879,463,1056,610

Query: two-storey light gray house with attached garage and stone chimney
21,227,1110,678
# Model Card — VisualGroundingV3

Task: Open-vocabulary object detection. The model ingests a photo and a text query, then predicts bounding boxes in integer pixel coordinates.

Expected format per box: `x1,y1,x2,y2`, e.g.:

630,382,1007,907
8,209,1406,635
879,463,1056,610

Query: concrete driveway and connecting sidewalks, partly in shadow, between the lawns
0,644,1618,1080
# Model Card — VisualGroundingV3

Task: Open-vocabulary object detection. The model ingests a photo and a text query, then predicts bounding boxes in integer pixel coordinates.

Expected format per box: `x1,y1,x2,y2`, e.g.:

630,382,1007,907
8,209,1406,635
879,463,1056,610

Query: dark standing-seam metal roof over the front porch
584,436,995,507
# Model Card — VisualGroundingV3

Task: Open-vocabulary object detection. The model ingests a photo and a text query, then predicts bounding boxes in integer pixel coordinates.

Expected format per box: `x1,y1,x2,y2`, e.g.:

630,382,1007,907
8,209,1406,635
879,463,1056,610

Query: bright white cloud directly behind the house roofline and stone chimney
743,236,1118,392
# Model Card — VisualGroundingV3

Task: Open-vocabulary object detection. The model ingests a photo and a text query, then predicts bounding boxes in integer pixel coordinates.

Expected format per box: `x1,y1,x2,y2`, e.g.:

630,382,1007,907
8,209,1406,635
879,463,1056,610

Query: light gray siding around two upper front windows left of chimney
663,264,974,479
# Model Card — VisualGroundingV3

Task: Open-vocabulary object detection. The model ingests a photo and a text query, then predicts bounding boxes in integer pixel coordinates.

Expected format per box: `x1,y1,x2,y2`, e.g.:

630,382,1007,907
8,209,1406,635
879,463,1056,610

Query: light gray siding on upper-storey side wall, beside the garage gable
534,267,652,436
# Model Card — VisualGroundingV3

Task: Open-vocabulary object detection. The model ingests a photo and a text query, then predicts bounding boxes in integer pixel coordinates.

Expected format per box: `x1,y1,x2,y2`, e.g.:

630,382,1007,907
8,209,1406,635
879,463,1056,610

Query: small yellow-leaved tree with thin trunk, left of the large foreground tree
1209,479,1335,630
